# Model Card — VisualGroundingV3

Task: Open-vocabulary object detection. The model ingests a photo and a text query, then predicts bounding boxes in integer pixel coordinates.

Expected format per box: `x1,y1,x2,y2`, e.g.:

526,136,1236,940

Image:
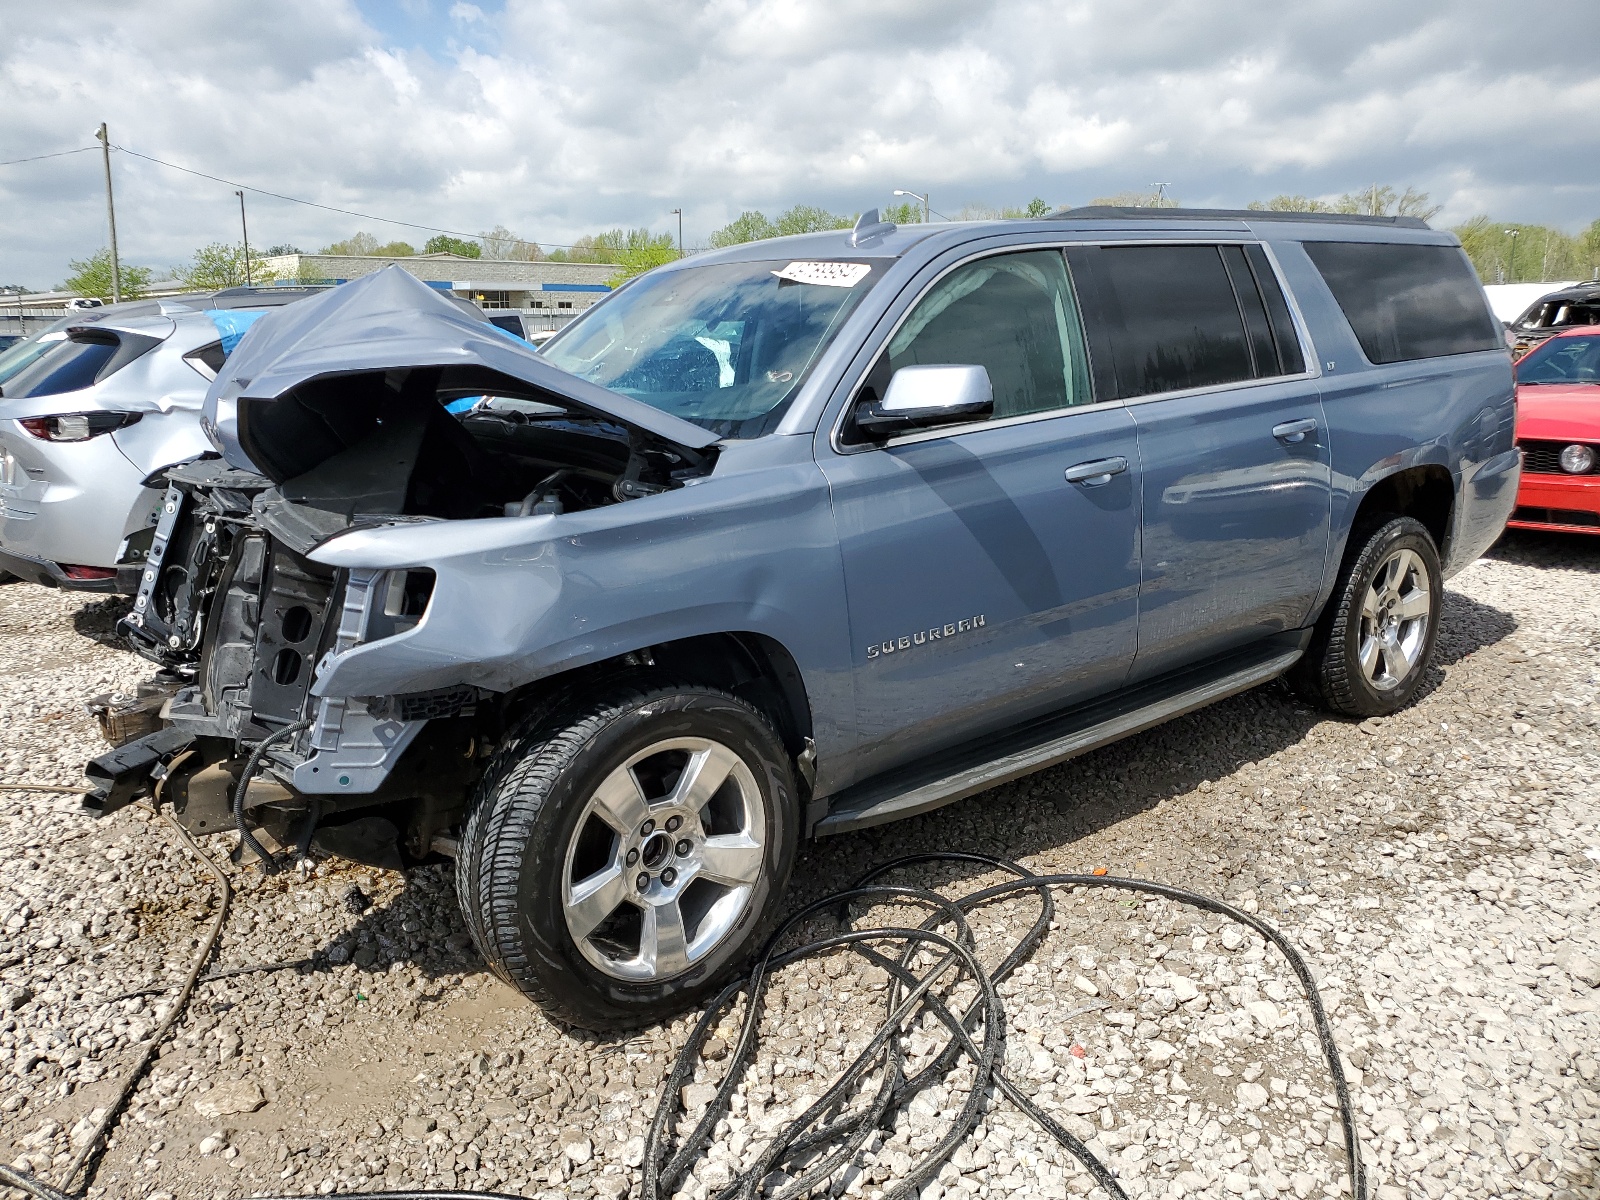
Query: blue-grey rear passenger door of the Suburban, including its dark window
1069,243,1331,680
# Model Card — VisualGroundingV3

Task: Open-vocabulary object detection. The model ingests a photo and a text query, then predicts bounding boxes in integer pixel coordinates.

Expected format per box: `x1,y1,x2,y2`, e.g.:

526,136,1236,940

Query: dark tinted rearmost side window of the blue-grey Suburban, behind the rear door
1306,242,1506,363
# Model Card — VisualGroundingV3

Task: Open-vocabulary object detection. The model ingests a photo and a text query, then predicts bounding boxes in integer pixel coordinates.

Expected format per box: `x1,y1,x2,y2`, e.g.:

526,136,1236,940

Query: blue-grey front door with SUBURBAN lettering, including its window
819,250,1139,782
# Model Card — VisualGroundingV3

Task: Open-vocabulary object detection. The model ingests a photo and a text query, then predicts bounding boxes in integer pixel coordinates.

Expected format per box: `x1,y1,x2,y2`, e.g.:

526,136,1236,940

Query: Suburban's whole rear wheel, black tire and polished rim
1288,517,1445,717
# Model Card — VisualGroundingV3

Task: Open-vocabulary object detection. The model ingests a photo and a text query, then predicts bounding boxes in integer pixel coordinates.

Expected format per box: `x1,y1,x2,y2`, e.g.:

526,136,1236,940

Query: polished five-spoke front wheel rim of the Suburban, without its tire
562,738,766,982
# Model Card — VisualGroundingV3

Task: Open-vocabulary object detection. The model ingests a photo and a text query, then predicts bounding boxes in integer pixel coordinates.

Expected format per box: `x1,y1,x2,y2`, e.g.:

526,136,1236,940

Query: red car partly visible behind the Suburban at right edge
1507,325,1600,534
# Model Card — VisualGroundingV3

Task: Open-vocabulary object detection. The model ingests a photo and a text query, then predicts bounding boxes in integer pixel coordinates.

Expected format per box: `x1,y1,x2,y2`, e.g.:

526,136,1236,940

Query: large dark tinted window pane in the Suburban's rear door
1069,246,1254,398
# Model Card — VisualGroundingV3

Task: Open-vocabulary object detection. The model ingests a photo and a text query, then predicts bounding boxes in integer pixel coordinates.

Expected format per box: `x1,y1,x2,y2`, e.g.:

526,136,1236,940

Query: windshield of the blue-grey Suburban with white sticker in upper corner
542,259,882,438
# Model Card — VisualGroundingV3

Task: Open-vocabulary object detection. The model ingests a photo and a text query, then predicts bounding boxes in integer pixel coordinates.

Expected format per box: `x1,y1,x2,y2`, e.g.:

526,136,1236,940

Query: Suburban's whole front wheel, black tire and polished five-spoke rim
456,685,798,1030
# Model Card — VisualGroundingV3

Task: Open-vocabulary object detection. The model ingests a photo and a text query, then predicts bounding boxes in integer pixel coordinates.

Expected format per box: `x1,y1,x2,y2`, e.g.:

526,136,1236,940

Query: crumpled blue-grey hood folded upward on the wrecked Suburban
203,266,718,470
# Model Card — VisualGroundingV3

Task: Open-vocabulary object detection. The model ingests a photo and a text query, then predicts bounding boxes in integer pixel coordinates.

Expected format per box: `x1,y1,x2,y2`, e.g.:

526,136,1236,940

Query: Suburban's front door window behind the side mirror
867,250,1094,419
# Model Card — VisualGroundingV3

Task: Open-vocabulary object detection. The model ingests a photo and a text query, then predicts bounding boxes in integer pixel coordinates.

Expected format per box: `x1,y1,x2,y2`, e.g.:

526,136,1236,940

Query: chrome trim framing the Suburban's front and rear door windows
827,234,1322,454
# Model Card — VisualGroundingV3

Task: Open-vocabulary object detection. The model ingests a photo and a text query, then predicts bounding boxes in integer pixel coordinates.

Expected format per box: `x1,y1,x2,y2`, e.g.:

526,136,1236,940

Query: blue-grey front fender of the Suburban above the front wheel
310,438,853,755
